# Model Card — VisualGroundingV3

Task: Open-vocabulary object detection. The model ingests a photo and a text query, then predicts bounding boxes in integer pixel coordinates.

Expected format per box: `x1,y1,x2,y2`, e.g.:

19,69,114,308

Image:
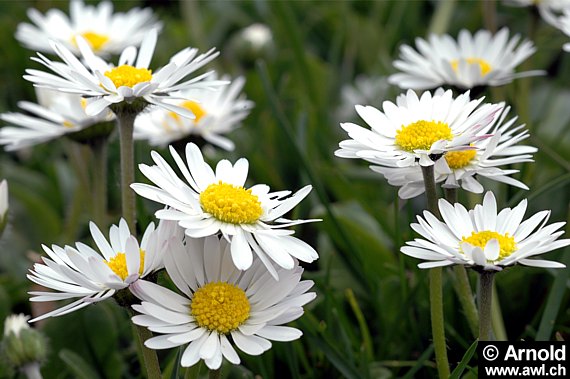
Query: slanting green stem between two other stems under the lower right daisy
444,188,479,337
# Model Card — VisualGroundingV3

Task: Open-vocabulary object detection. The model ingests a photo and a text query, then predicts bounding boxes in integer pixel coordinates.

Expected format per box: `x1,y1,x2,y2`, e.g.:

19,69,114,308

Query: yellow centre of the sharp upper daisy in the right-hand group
396,120,453,151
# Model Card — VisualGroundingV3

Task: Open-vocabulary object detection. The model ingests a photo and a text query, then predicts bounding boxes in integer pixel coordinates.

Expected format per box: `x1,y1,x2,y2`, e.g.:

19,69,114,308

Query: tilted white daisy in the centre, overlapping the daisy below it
131,143,320,278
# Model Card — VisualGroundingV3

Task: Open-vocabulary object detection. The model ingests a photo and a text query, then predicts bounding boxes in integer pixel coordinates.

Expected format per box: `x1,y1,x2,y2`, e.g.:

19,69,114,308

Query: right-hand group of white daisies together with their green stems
335,1,570,356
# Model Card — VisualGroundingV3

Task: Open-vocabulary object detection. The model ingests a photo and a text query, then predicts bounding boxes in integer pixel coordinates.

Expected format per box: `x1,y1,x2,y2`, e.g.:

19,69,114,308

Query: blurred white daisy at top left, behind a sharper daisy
16,0,162,56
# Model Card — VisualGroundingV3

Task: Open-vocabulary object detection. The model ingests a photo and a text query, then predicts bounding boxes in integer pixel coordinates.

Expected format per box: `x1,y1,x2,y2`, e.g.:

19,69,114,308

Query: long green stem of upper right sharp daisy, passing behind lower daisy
422,165,450,379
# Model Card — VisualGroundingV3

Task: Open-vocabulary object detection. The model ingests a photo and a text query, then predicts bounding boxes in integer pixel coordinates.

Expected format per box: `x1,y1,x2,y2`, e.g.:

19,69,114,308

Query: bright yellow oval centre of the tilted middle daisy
200,180,263,224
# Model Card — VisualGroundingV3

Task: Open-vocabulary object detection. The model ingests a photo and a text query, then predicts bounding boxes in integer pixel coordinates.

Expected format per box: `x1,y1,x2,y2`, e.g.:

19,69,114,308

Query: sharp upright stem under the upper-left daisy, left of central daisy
117,112,137,232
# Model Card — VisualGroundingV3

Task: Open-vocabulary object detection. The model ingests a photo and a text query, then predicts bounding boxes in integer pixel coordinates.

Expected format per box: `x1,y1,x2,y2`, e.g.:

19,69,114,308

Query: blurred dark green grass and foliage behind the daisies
0,0,570,378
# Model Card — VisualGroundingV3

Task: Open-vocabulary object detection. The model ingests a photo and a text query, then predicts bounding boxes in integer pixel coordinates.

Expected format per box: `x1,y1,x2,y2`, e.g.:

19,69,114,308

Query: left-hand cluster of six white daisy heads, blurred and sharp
0,0,318,370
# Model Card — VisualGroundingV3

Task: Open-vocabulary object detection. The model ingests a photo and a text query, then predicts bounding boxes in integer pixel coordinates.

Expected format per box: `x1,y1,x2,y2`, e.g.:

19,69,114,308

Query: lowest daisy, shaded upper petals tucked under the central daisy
131,236,316,370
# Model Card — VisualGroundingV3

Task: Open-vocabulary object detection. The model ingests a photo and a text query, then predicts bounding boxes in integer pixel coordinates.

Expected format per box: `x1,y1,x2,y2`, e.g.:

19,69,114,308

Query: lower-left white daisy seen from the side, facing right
28,219,183,322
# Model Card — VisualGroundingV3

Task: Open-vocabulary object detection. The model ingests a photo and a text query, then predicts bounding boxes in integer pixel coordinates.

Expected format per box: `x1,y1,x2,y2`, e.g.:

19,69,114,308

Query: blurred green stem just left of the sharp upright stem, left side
90,137,108,228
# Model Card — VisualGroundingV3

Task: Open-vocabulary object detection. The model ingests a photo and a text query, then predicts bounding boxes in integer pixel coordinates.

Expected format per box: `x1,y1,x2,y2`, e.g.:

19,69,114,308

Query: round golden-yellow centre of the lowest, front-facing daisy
190,282,251,334
